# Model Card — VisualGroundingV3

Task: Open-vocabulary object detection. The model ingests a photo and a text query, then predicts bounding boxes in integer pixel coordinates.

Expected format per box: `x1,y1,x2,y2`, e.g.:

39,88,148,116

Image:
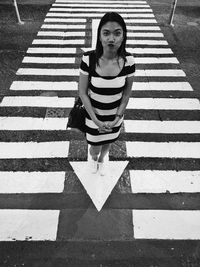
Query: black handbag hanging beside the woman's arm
67,97,86,133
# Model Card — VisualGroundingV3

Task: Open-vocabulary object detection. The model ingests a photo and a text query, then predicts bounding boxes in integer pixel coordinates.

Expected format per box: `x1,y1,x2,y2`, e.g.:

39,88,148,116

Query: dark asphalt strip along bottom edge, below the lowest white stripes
0,240,200,267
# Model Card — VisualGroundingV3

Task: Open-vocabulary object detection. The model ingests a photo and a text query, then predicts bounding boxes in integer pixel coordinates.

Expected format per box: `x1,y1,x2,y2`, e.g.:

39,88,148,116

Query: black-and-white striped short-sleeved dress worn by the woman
80,50,135,146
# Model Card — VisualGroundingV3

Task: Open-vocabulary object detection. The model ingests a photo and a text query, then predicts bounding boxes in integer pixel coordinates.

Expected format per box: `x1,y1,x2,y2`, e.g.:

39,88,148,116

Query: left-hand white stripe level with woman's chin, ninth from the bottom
27,47,76,54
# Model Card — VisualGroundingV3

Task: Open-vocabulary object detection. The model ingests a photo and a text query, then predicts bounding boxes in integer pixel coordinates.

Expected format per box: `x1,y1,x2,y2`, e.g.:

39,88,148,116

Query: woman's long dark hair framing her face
95,12,127,65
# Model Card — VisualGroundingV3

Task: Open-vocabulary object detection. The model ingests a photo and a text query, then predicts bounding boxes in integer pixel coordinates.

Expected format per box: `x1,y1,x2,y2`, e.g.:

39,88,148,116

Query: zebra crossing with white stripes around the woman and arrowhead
0,0,200,255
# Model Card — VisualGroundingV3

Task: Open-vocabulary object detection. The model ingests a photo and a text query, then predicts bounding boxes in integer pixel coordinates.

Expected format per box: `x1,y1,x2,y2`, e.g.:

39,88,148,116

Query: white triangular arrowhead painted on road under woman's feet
70,149,128,211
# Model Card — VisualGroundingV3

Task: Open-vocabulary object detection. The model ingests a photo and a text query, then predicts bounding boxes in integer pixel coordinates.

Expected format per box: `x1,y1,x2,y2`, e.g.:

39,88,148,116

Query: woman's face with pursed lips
100,21,124,52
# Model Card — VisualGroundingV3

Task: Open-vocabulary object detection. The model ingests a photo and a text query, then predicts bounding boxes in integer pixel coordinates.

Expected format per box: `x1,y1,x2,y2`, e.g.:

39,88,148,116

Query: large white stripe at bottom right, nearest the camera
133,210,200,240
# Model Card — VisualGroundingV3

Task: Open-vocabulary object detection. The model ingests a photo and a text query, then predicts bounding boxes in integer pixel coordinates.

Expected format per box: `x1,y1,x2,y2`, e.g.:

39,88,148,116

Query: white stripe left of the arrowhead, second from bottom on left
0,171,65,194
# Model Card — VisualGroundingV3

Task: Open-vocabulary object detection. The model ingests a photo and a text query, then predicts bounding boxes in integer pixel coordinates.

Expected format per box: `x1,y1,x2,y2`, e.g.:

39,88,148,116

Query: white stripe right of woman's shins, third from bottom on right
126,142,200,158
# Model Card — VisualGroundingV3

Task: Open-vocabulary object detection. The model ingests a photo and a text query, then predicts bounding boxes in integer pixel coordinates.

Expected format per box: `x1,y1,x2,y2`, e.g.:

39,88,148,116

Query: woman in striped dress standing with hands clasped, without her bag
79,12,135,175
